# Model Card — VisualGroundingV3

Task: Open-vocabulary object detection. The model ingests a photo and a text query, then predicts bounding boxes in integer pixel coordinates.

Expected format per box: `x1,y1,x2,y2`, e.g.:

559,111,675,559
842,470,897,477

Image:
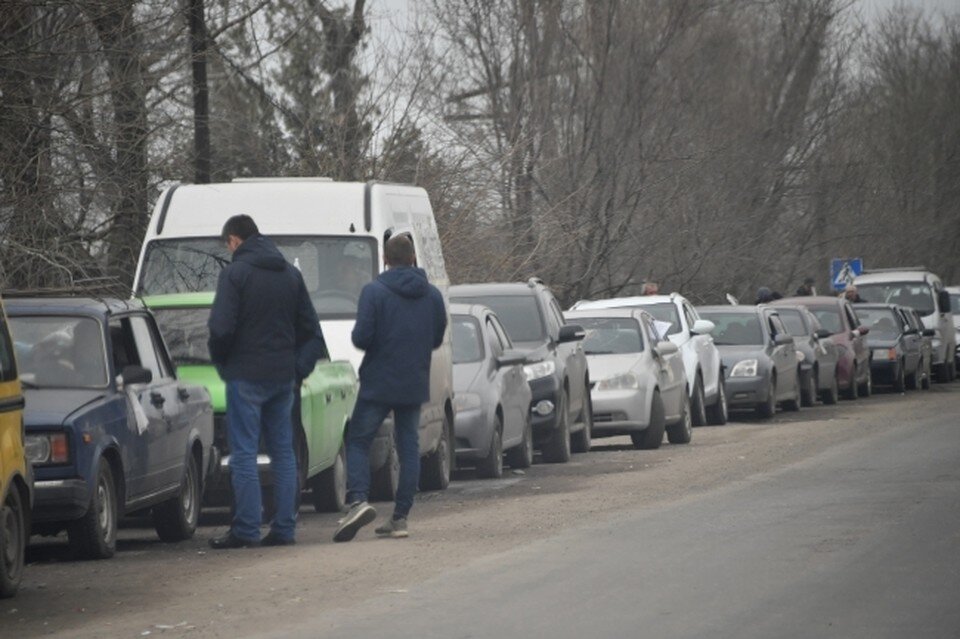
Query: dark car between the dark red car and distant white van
854,304,932,393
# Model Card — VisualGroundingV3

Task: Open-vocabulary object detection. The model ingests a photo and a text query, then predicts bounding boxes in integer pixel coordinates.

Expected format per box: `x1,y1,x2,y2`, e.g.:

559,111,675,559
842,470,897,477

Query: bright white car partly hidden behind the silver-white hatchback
570,293,727,426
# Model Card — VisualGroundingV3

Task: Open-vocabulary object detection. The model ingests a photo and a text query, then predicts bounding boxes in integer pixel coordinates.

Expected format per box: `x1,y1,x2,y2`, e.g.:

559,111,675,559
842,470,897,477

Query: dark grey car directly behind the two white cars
697,305,800,417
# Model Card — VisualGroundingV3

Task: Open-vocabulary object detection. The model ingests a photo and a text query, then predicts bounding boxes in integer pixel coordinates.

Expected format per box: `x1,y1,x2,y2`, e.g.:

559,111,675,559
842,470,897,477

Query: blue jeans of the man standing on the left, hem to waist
227,380,297,539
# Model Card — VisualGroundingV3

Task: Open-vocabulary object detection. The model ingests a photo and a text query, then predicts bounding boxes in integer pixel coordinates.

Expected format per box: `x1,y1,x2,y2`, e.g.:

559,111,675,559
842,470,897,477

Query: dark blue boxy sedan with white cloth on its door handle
6,297,216,558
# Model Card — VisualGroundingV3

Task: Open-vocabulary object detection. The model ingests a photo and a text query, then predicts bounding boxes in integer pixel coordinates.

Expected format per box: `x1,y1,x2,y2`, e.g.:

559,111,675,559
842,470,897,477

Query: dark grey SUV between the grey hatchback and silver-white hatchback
450,279,593,462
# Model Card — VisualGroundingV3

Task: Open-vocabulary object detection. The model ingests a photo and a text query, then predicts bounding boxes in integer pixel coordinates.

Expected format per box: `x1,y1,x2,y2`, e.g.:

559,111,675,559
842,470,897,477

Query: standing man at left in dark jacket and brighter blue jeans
208,215,325,549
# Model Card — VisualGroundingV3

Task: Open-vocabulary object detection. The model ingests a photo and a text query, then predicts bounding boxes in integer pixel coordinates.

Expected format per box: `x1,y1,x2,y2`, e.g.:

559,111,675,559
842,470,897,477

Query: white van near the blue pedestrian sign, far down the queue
853,266,957,382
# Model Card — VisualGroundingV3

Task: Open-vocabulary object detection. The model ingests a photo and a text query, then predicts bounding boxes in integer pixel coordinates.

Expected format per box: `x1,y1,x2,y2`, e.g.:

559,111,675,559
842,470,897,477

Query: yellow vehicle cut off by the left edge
0,305,33,598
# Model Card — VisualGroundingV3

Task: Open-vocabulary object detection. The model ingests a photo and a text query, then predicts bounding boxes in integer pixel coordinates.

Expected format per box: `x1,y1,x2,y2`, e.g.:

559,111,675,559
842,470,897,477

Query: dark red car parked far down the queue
771,296,873,399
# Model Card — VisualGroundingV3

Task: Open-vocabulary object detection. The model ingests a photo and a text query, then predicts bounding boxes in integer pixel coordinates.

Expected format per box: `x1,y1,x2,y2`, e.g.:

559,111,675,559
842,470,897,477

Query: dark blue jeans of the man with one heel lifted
347,399,420,517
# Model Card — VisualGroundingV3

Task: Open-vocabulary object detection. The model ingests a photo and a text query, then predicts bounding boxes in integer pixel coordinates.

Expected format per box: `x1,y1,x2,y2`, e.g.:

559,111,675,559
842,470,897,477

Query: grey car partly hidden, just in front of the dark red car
777,304,840,406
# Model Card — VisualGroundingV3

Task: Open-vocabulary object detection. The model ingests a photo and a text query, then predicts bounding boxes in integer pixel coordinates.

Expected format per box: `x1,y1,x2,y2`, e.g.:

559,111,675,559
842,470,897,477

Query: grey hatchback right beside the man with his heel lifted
450,304,533,478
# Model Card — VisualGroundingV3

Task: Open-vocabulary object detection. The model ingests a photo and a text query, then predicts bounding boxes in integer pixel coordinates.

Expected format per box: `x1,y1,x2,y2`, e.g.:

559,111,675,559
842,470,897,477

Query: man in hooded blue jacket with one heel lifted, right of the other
333,235,447,541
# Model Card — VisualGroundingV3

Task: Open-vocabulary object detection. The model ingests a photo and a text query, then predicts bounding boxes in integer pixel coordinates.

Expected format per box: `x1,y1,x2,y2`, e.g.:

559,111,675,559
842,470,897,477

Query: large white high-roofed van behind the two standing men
134,178,454,499
